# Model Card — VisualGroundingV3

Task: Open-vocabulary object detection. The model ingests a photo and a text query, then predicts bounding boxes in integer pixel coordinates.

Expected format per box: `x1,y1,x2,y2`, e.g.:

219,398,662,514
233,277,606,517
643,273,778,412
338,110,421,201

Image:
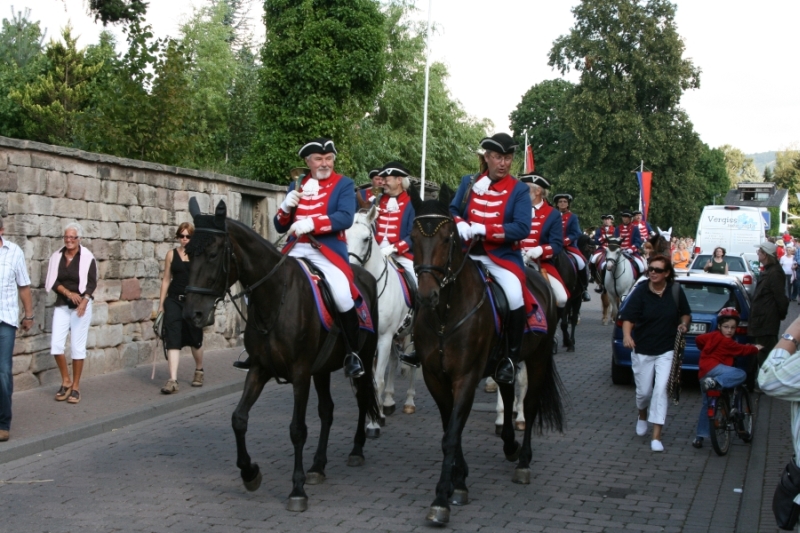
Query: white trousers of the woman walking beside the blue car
631,350,674,425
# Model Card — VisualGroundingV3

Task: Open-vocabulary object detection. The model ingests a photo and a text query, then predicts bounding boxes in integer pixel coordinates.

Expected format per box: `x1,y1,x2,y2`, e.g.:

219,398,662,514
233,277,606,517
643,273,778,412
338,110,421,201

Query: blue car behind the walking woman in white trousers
611,272,751,385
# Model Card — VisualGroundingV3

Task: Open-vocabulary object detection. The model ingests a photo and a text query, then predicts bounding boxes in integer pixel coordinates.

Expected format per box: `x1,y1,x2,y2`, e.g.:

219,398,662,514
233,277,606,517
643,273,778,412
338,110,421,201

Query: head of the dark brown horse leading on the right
408,185,463,307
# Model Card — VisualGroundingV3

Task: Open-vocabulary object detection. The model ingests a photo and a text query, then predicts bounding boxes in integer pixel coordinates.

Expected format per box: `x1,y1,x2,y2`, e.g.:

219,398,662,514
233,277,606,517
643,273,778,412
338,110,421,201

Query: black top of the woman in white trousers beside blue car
620,282,692,355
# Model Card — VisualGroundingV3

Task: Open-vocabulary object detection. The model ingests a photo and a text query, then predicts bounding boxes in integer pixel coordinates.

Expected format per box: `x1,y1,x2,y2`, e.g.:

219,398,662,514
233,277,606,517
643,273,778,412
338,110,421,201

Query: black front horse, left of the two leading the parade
183,199,378,511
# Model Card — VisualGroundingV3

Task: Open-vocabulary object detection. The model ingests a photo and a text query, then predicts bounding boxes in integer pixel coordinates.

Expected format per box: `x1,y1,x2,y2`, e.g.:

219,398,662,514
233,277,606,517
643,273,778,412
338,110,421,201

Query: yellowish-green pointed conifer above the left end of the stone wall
10,25,102,145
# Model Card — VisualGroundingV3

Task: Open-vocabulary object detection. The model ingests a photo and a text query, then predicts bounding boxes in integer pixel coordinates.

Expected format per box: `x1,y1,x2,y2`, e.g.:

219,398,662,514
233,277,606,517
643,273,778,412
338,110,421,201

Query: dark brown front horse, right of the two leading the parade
409,186,563,524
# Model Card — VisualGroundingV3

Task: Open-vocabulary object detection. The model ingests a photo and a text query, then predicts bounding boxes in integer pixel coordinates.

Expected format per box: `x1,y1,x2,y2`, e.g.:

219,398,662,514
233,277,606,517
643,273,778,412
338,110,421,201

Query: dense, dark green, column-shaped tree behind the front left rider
249,0,386,183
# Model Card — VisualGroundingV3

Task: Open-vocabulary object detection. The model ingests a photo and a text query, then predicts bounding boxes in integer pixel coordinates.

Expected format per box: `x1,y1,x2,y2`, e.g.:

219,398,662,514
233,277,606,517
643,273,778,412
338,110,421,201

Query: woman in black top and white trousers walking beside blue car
620,255,692,452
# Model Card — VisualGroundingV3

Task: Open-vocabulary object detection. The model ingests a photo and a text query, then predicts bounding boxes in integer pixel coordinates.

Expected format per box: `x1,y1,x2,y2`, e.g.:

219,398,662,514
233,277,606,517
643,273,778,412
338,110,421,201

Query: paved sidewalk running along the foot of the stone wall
0,347,246,464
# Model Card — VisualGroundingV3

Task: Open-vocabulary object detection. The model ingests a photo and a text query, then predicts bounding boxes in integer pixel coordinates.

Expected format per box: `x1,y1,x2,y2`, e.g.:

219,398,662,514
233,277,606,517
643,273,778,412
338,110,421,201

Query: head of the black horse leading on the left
183,197,237,327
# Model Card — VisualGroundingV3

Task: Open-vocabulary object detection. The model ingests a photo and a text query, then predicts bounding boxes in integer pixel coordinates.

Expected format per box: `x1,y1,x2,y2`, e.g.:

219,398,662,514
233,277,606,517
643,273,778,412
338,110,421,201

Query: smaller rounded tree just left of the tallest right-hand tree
509,79,575,176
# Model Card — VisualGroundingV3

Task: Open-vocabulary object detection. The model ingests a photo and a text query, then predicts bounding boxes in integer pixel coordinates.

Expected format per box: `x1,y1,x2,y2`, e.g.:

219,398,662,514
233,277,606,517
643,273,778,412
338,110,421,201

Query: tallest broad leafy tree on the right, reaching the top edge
549,0,705,234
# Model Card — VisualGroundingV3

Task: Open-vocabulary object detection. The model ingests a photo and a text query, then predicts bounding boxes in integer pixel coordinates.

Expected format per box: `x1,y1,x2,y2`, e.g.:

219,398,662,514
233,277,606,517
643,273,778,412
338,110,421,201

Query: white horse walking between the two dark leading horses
345,206,416,438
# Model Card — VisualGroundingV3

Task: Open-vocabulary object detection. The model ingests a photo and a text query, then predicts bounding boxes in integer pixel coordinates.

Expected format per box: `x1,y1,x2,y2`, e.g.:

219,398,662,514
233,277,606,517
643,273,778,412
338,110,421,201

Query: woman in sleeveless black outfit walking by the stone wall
158,222,203,394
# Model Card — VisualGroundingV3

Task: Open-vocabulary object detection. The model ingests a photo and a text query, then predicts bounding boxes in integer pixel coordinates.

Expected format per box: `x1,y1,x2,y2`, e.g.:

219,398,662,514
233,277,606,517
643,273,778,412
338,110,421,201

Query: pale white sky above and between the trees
10,0,800,154
